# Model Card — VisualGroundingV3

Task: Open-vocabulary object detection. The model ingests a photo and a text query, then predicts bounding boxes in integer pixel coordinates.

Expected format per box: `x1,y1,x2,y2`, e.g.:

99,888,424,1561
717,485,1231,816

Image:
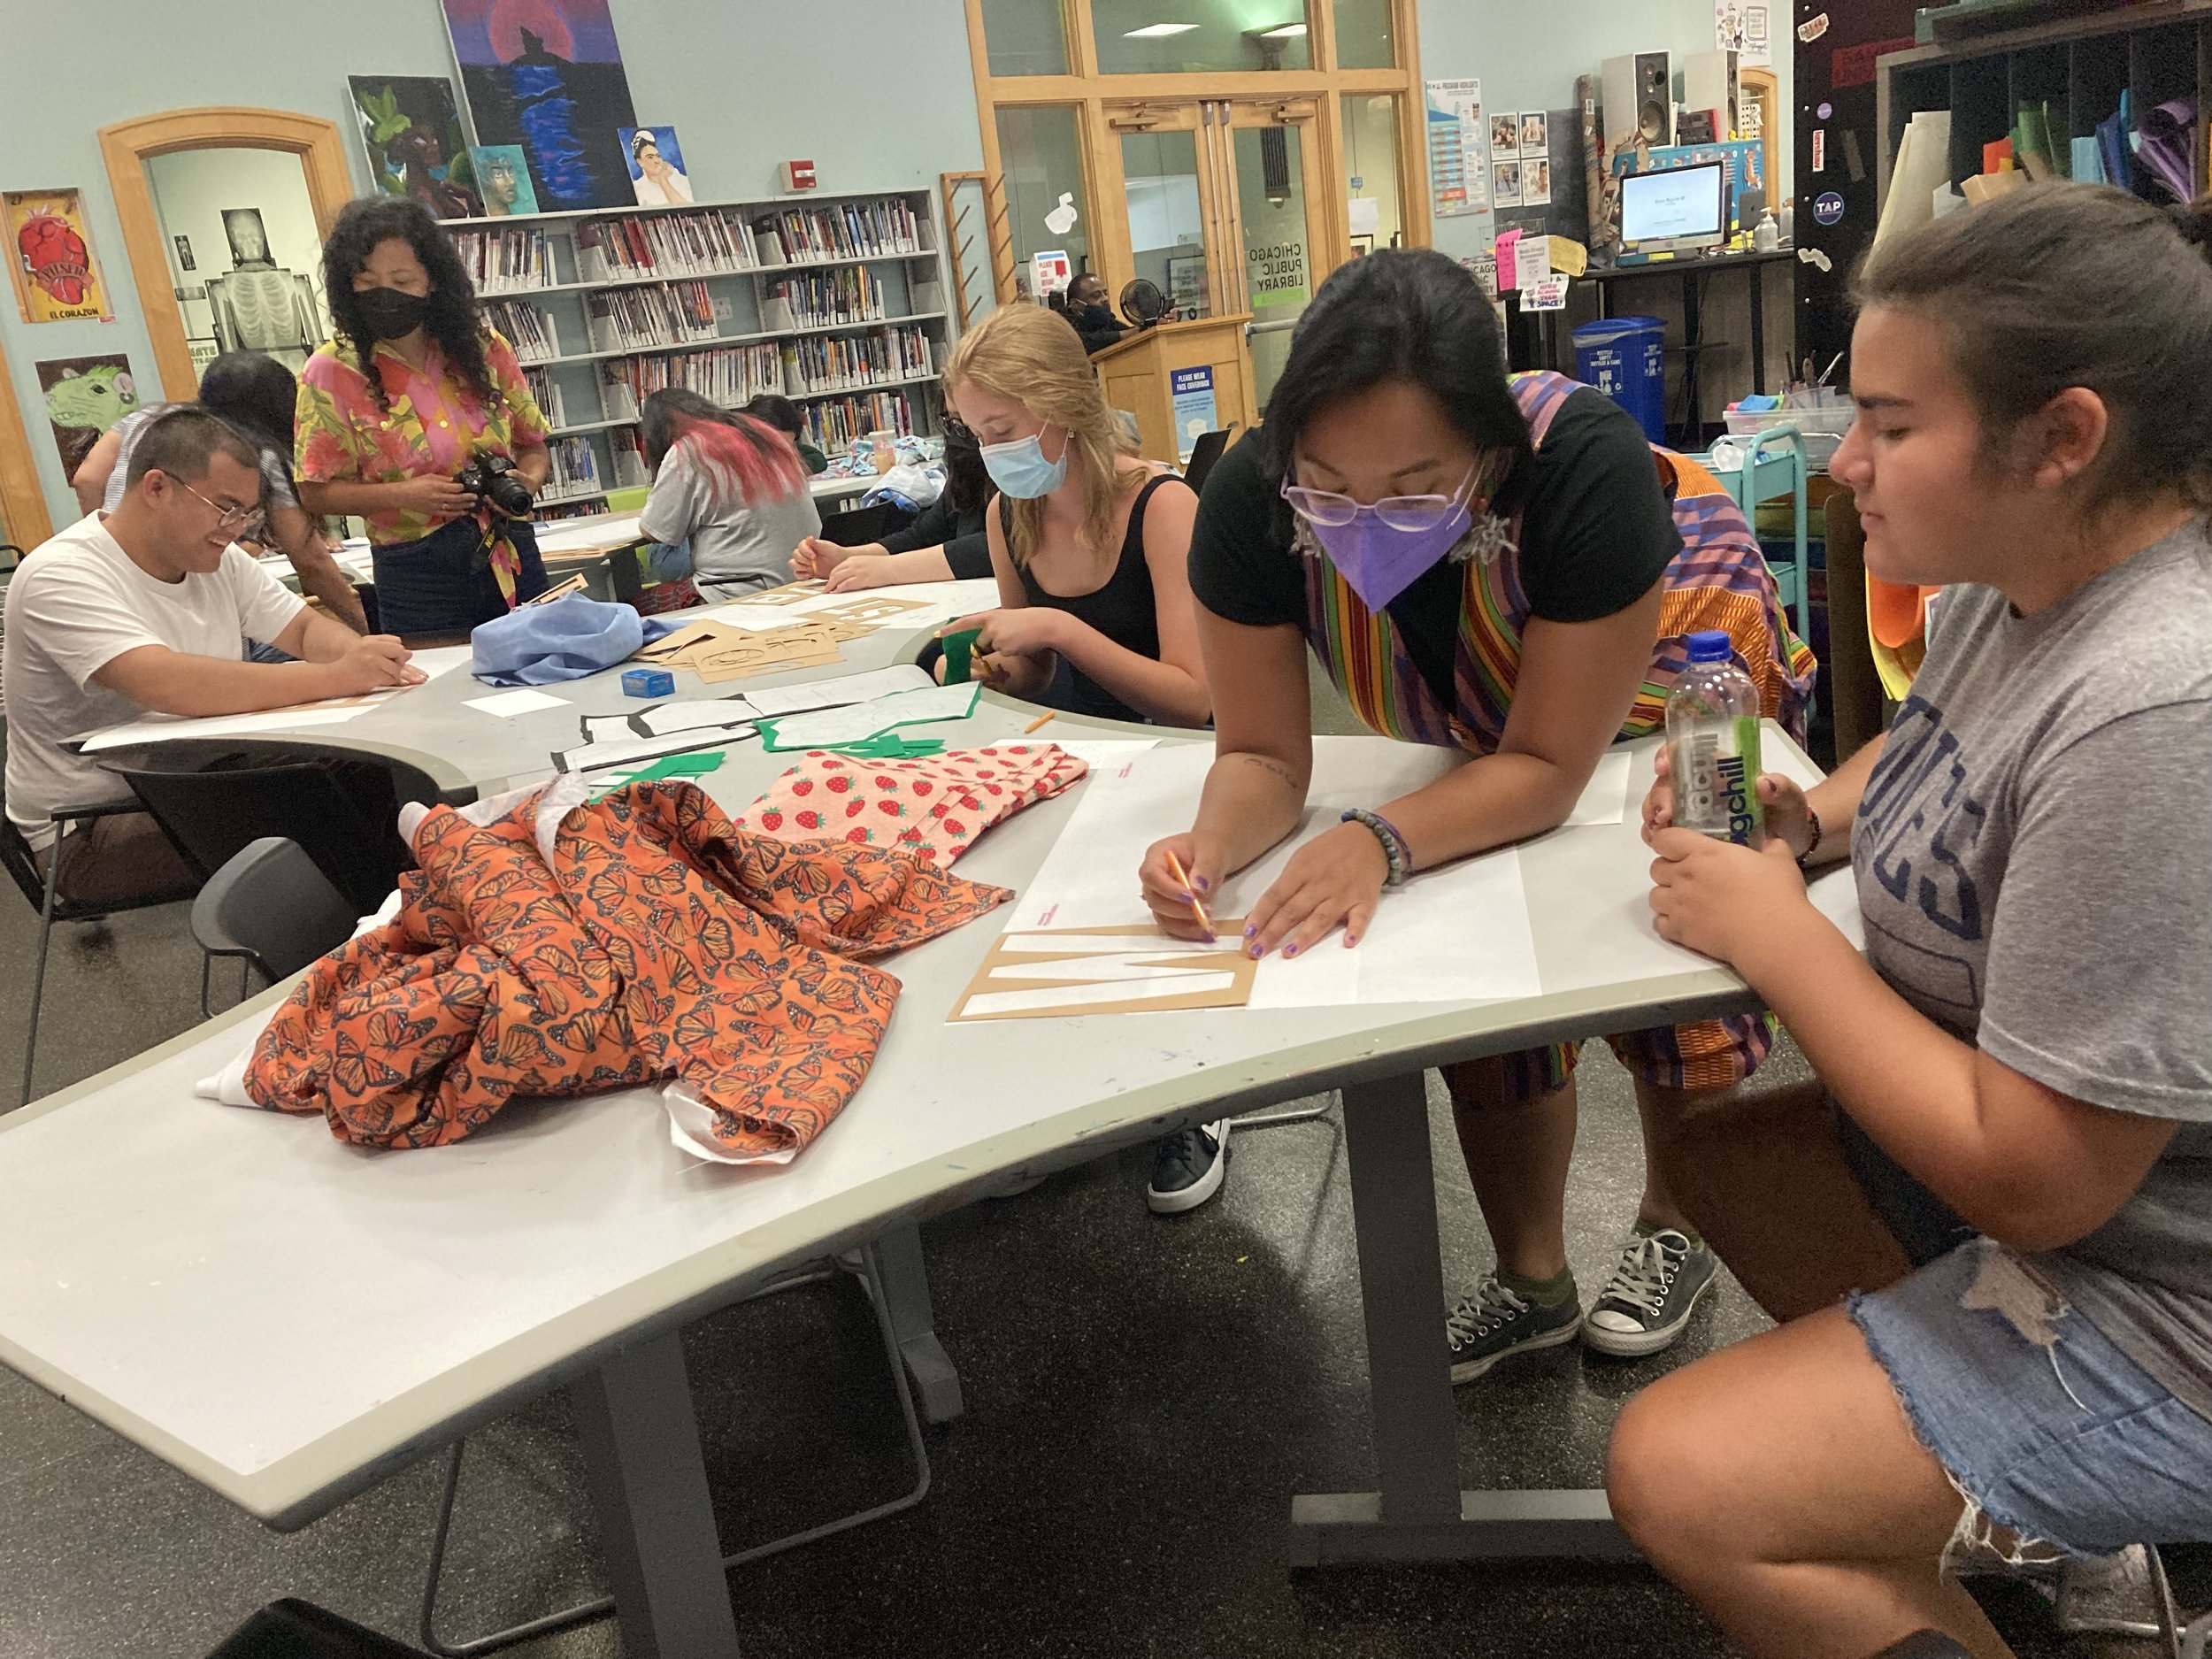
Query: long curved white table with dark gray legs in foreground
0,606,1849,1659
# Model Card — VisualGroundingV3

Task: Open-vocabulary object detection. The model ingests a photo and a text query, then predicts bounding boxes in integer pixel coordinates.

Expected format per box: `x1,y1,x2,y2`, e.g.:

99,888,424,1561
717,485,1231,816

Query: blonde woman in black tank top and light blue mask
945,305,1212,726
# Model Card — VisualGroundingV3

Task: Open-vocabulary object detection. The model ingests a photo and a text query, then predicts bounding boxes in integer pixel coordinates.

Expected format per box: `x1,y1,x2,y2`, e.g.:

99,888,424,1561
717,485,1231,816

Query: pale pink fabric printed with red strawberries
737,743,1091,867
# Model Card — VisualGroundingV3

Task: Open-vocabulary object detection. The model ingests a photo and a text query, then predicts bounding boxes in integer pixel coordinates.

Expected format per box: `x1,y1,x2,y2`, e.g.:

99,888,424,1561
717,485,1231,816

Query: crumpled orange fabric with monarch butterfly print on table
246,783,1011,1159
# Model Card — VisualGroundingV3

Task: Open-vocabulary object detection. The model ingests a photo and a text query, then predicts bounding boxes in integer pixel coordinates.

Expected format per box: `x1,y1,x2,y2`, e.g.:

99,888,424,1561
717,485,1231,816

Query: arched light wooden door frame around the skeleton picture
100,109,354,403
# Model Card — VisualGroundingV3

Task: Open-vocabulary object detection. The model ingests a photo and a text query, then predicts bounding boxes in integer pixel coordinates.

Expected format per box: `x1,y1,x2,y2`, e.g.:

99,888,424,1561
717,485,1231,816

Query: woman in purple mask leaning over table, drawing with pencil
1141,250,1812,1383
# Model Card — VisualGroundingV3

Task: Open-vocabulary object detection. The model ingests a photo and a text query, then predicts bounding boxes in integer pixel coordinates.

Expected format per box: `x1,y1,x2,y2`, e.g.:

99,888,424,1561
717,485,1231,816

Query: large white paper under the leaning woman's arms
1007,737,1542,1009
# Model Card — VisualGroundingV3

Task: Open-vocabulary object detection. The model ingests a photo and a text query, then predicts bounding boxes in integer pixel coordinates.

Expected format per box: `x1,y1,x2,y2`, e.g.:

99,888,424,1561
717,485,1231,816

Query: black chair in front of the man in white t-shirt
100,739,438,916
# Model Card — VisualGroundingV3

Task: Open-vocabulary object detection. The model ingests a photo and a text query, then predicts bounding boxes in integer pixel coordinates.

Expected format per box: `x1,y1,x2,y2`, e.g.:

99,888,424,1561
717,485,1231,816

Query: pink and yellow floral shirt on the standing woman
296,330,549,547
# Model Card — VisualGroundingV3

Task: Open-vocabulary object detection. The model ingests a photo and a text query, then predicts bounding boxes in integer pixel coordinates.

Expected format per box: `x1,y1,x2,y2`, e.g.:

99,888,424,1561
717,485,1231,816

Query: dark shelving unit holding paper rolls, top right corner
1876,0,2212,214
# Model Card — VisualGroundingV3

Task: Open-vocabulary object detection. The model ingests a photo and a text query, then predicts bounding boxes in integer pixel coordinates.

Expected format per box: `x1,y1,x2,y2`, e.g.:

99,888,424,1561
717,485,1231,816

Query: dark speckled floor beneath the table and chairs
0,668,2177,1659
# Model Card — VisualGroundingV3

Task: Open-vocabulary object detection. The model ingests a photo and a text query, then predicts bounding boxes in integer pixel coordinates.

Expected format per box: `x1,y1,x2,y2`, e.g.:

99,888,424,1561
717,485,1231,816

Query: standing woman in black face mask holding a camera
296,197,549,635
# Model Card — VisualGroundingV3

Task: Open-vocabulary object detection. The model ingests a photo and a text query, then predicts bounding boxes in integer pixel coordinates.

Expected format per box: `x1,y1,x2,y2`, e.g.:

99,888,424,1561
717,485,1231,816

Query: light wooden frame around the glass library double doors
963,0,1432,303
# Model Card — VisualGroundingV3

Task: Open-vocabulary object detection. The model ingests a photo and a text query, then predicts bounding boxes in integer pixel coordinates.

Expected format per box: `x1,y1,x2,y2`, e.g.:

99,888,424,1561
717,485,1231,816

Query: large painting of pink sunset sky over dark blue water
442,0,637,212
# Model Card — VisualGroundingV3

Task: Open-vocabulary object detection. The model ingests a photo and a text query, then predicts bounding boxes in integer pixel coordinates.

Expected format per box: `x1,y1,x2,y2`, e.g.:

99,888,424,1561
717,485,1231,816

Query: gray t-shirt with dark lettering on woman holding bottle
1852,522,2212,1418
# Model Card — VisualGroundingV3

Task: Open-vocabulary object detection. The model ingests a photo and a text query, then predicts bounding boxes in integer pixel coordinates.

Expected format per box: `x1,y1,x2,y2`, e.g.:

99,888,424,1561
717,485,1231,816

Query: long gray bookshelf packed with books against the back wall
445,190,949,518
